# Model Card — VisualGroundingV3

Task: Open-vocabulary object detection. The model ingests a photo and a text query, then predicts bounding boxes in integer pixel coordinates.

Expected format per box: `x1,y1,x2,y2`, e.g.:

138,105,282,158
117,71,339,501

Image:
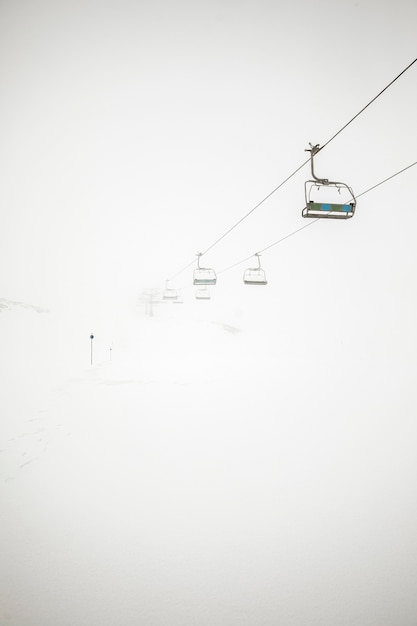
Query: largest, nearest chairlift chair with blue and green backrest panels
302,144,356,219
